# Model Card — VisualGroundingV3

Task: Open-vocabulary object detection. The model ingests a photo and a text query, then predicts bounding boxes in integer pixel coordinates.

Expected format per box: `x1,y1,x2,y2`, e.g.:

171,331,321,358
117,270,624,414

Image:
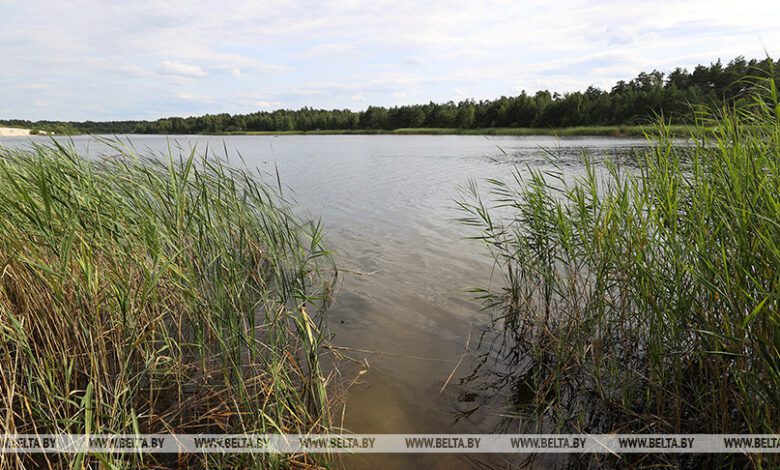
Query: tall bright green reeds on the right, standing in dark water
461,76,780,468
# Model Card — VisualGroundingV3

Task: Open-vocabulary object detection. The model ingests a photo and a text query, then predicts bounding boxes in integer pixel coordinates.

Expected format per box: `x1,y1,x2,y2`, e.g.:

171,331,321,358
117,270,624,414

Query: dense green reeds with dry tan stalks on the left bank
0,144,333,468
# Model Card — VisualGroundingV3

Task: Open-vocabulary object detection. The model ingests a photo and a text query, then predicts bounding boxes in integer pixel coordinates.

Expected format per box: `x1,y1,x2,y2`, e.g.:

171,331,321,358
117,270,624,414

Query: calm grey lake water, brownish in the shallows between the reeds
0,135,646,468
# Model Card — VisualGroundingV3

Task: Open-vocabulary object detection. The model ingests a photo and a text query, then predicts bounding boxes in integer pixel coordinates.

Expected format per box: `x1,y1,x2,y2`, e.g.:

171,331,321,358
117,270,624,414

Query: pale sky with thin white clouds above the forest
0,0,780,120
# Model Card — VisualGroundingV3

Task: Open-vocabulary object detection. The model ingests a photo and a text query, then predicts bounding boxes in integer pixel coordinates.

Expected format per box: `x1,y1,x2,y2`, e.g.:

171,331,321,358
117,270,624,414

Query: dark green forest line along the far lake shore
0,57,780,134
